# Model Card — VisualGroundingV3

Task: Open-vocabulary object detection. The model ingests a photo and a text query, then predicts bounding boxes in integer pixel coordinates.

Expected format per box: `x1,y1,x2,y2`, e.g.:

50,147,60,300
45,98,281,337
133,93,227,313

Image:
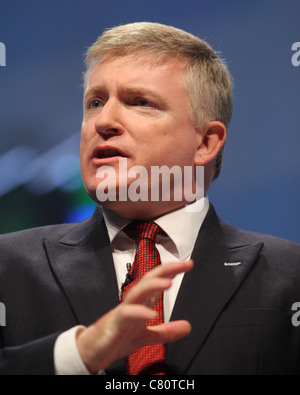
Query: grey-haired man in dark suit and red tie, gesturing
0,23,300,374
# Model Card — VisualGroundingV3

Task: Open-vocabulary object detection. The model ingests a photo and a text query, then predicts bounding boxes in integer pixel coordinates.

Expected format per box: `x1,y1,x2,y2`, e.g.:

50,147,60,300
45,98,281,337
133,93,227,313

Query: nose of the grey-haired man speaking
95,99,124,139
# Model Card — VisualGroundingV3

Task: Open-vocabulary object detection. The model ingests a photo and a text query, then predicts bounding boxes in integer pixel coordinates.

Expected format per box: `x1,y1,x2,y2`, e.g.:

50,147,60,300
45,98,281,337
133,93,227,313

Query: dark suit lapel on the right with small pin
167,207,263,374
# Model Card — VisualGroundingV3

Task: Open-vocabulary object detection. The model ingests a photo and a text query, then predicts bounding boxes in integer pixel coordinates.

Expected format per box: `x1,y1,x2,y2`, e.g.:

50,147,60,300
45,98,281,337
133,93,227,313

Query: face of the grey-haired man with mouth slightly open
80,55,201,218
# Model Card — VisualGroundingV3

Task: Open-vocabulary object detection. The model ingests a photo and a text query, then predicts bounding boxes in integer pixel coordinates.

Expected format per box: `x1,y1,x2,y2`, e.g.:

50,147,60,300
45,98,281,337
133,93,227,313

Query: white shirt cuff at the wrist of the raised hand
54,325,105,375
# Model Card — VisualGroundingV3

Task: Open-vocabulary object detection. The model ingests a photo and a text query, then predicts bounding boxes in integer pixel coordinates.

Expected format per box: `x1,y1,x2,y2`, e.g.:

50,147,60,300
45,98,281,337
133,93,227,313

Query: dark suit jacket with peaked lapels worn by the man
0,206,300,375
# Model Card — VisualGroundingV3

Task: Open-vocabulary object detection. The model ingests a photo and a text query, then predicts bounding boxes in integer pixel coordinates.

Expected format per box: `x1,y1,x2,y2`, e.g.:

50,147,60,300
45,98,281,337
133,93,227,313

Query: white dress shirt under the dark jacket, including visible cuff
54,197,209,375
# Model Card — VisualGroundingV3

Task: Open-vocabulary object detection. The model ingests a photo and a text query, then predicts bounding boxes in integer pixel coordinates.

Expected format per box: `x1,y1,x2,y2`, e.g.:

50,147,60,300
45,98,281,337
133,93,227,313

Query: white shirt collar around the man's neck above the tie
102,197,209,260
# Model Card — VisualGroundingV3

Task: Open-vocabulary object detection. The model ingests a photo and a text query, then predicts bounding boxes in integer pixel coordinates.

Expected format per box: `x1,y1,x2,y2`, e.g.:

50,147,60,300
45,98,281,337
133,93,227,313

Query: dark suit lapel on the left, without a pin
44,208,119,325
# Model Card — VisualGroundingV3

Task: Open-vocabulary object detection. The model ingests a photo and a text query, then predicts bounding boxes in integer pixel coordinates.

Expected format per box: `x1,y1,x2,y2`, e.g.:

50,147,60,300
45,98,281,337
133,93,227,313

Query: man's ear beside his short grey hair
194,121,227,166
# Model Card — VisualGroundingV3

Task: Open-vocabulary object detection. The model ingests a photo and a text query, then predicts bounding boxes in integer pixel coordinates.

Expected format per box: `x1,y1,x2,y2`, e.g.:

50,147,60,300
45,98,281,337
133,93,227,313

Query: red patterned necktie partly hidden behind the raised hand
121,221,166,375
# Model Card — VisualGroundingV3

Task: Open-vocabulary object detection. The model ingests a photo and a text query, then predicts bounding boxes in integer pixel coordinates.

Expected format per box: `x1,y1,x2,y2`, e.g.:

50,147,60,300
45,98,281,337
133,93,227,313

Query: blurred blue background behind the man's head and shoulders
0,0,300,242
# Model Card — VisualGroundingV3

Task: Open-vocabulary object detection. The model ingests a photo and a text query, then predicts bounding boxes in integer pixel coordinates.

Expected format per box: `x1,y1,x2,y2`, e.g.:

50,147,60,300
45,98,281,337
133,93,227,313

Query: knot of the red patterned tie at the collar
124,221,166,243
